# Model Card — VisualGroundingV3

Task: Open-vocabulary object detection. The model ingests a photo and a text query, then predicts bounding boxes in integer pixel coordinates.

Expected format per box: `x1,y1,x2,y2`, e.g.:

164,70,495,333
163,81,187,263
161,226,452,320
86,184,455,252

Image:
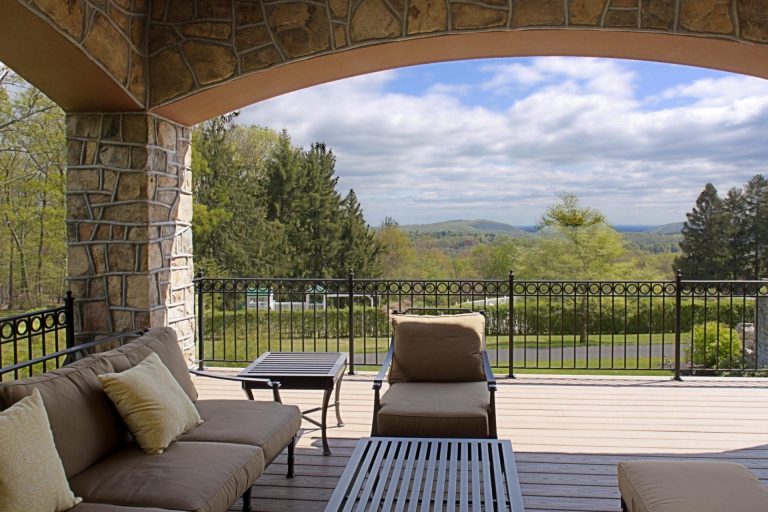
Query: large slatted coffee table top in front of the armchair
325,437,524,512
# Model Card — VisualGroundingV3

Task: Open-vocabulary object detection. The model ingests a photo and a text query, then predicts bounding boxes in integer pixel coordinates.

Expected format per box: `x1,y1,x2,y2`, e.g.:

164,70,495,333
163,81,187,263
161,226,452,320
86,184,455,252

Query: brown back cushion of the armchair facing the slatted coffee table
389,313,485,383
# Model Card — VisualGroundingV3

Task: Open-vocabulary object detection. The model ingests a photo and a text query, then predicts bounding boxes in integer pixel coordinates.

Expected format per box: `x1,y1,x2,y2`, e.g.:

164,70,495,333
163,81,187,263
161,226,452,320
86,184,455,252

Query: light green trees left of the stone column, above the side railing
0,65,65,309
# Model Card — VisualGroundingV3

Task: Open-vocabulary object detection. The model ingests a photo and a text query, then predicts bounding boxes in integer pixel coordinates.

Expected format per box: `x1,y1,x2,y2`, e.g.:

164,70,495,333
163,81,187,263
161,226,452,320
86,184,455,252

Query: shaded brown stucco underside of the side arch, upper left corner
0,0,143,112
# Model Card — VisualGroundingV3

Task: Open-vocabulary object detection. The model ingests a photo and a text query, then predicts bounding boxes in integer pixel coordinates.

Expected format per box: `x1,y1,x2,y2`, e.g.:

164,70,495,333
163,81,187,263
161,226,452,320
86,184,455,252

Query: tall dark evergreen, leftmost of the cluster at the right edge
675,183,733,279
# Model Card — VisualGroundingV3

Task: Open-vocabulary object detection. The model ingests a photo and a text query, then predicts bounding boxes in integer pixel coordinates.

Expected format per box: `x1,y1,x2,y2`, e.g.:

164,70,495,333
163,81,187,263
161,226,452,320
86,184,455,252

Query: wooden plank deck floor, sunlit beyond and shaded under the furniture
196,375,768,512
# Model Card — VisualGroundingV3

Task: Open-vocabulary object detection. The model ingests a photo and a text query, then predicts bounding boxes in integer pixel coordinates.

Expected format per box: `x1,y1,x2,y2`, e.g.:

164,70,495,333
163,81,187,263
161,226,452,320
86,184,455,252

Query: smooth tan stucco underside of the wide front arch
153,29,768,125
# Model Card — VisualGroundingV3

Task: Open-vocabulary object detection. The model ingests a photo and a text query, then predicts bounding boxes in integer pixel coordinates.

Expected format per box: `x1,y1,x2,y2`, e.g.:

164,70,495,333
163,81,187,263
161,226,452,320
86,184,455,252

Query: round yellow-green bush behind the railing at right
689,322,742,370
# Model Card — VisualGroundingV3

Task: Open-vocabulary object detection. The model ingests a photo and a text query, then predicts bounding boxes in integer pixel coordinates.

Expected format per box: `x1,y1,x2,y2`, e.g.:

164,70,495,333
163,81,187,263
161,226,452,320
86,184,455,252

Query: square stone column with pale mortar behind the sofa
67,113,194,355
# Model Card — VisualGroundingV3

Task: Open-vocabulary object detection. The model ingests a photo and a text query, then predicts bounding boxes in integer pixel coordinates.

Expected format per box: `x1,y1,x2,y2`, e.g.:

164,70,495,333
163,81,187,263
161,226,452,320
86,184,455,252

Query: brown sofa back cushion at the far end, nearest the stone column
101,327,197,402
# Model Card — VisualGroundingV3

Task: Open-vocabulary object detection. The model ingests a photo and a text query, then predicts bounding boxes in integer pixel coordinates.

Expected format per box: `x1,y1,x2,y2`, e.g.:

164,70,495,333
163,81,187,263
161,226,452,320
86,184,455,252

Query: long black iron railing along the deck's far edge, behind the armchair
195,273,768,378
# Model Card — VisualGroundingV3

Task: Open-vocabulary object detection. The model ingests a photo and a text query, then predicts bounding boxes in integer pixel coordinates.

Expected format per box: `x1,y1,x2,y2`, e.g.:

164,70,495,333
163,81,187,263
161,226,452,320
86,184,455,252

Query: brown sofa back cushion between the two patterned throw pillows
0,356,130,478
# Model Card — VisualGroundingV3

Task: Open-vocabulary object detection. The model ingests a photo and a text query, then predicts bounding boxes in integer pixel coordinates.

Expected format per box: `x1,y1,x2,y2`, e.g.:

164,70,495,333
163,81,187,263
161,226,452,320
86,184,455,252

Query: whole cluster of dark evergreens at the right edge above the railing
674,174,768,279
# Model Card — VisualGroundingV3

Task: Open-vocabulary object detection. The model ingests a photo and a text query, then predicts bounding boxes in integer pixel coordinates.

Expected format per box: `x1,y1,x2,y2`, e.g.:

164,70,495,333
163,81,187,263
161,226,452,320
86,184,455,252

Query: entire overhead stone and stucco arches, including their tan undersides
0,0,768,124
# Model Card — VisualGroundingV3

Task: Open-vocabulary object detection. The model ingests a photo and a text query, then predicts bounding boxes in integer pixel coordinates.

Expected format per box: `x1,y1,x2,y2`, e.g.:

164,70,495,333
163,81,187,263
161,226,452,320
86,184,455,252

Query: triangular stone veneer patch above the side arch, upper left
19,0,150,105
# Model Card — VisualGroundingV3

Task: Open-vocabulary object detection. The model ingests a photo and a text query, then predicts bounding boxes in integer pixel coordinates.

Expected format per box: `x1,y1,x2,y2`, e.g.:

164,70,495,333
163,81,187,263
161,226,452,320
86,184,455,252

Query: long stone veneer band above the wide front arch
148,0,768,107
